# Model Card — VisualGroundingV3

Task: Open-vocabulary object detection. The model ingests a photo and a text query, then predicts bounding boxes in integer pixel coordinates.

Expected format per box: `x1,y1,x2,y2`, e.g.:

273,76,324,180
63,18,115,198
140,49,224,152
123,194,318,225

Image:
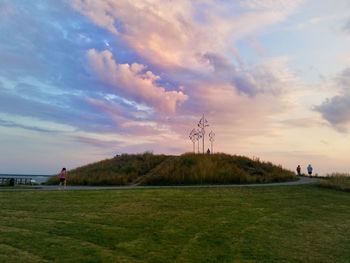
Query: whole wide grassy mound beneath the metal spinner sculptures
48,152,297,185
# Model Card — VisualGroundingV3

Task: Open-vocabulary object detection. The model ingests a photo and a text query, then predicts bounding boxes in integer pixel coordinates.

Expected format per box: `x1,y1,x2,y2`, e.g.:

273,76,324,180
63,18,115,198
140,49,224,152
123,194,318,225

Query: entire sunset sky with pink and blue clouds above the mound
0,0,350,175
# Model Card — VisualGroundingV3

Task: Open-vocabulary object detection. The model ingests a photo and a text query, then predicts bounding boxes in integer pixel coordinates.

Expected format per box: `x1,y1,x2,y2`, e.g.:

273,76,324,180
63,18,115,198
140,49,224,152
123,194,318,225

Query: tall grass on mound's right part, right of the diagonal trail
139,153,297,185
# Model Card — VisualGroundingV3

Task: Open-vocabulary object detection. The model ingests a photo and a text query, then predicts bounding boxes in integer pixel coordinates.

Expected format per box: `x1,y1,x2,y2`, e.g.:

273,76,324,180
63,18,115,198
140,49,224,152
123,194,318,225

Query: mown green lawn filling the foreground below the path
0,186,350,263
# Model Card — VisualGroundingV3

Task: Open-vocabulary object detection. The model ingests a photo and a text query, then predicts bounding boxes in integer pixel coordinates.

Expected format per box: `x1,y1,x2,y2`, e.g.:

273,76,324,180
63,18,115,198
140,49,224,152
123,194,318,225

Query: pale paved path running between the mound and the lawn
0,177,319,192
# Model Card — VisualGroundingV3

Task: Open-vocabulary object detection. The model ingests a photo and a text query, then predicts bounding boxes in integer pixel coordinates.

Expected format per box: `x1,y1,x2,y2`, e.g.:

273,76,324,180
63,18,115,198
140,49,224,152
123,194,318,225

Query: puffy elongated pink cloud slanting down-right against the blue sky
87,49,188,114
